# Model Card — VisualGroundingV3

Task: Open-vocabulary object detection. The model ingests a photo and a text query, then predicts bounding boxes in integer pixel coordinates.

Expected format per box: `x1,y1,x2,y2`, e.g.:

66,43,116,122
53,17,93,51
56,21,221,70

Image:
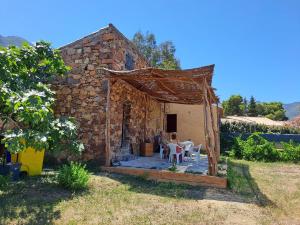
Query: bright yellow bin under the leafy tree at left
11,147,45,176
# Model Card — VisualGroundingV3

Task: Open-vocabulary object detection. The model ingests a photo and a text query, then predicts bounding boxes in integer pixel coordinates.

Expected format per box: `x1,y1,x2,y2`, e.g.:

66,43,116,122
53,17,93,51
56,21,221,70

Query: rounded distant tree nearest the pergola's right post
222,95,244,116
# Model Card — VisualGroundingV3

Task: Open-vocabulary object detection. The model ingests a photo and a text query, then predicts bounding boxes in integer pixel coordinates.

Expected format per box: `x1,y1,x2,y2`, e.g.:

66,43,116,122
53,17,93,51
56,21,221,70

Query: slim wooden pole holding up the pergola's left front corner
105,79,111,166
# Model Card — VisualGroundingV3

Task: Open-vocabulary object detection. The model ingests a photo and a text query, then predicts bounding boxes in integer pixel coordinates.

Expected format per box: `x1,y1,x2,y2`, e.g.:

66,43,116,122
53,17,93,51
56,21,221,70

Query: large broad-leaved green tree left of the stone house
0,41,83,153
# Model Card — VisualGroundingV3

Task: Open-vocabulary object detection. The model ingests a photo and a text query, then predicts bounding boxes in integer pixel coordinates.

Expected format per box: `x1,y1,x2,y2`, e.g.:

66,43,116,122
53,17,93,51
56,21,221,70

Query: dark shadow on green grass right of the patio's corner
227,160,276,207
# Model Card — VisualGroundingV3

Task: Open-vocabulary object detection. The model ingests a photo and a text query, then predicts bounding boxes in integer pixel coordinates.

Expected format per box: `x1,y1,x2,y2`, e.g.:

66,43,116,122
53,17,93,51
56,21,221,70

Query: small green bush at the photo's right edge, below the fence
280,140,300,162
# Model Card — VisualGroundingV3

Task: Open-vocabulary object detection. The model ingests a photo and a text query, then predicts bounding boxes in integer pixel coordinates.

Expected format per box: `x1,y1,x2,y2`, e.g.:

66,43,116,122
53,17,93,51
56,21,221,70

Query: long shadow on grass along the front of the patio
100,166,268,203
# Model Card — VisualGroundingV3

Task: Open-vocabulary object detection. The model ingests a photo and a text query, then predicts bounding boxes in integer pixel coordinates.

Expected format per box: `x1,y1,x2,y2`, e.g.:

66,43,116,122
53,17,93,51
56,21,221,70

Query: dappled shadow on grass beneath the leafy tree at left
0,172,88,225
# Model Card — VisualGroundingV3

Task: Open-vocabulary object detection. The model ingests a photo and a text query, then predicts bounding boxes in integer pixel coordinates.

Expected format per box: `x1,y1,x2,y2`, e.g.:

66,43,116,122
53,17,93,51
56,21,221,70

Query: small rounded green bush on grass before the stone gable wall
57,162,90,190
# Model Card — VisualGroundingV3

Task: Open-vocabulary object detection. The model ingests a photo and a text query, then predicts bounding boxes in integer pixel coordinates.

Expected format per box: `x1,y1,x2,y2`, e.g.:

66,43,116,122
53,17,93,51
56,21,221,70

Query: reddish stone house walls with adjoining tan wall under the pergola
53,22,218,164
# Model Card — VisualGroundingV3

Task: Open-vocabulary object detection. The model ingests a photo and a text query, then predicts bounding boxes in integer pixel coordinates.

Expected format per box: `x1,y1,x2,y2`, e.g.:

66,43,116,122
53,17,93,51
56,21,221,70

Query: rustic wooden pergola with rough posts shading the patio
101,65,219,175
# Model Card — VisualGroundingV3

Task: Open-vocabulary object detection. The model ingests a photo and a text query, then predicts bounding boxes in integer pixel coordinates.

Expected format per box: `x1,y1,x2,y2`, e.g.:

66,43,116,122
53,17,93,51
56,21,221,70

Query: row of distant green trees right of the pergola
222,95,288,121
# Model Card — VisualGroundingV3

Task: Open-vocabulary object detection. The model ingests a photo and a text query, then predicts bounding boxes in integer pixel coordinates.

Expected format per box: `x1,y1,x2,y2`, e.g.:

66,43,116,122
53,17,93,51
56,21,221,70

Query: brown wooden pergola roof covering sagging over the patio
102,65,218,104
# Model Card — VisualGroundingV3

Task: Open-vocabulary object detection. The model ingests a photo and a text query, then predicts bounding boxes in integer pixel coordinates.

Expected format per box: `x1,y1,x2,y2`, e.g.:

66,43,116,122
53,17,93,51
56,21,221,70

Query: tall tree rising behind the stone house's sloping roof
132,32,180,69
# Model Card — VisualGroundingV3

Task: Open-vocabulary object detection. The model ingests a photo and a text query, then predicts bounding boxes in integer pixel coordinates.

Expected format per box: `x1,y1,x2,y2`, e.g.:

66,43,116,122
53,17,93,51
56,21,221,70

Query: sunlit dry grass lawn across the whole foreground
0,160,300,225
